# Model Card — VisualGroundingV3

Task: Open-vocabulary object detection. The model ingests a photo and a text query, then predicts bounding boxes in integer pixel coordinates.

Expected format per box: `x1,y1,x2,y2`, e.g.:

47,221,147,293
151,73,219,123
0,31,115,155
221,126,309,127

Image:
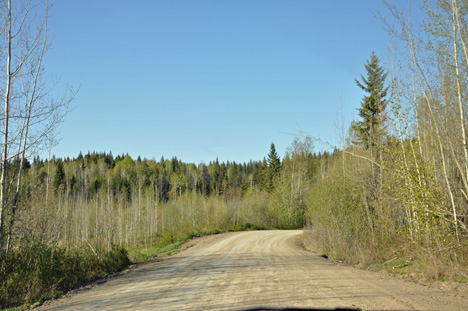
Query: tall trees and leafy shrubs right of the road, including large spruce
308,0,468,282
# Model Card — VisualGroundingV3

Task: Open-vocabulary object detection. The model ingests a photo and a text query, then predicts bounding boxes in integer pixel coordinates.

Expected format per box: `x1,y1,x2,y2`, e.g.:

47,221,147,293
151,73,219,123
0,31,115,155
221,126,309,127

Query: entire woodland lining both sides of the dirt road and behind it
0,0,468,307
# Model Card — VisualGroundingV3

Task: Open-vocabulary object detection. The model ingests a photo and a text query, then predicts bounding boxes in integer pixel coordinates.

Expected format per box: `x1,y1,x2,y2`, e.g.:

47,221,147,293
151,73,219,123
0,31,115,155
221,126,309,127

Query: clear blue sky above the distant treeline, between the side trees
43,0,412,163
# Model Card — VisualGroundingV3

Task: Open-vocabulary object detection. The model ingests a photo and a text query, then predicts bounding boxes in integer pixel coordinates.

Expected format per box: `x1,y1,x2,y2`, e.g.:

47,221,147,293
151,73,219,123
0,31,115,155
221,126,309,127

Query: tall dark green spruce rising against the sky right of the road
352,51,388,149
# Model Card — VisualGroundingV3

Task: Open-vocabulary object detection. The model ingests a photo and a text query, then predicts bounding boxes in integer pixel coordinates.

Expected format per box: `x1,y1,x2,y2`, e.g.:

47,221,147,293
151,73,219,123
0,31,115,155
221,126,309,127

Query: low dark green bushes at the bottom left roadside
0,243,130,308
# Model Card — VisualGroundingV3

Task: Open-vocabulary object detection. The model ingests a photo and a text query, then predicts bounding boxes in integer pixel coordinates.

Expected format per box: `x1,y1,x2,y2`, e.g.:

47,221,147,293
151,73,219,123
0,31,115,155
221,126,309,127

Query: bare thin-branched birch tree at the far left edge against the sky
0,0,74,270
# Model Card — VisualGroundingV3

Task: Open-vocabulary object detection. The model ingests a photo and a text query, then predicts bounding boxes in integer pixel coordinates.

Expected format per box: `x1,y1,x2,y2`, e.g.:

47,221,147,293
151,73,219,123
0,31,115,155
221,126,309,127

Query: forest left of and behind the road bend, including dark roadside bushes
2,143,318,304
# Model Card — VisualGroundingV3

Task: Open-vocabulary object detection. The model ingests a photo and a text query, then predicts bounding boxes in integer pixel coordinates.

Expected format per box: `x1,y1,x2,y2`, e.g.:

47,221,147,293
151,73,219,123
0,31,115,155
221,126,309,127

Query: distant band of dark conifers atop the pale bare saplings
42,152,272,202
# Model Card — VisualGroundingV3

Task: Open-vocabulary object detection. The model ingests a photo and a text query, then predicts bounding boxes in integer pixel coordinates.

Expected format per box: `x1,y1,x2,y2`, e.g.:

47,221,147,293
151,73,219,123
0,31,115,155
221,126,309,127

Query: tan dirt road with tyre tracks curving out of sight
40,231,468,311
